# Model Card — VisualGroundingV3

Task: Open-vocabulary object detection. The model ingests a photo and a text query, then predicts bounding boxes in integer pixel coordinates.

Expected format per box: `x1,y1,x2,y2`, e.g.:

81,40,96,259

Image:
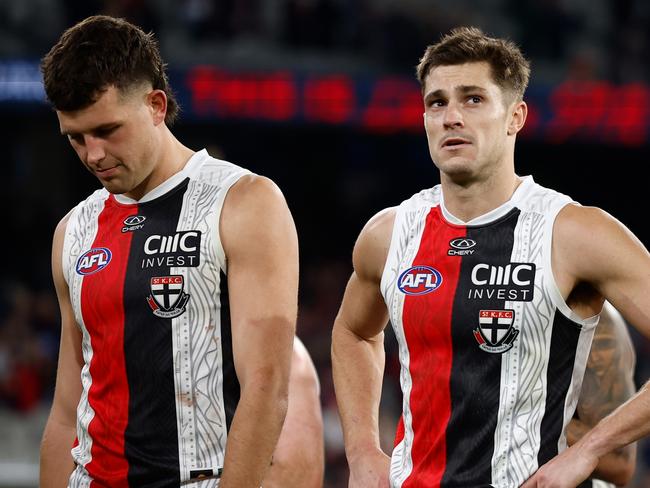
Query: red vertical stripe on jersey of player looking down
81,197,137,488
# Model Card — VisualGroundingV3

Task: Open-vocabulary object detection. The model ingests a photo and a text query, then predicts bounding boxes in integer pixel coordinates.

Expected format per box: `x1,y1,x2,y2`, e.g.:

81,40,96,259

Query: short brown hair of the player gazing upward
417,27,530,101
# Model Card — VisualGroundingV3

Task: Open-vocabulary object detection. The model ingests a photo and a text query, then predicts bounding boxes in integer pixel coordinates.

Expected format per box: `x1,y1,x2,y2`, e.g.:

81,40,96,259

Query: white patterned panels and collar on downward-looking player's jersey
62,150,251,488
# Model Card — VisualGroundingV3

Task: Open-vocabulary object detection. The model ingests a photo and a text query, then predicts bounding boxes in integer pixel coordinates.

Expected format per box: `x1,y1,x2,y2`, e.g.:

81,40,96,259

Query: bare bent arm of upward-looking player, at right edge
523,205,650,488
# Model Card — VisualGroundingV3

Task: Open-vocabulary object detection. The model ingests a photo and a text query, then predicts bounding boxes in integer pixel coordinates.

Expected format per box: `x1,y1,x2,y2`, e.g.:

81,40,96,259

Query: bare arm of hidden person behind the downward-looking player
262,337,325,488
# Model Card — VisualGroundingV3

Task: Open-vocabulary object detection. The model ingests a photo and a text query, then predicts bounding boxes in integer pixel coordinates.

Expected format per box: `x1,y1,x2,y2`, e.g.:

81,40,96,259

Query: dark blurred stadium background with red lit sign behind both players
0,0,650,488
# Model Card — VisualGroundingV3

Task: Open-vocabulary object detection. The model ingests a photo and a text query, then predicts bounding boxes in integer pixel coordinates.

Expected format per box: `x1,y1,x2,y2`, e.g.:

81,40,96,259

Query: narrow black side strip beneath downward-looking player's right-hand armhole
219,271,240,431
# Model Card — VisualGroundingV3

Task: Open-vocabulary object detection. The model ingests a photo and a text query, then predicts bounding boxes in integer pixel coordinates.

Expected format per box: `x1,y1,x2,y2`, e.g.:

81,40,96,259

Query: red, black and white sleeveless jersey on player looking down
62,150,249,488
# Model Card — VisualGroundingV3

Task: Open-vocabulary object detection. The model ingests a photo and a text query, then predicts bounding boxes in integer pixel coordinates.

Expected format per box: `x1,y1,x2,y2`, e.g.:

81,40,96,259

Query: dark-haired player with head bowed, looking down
41,16,322,488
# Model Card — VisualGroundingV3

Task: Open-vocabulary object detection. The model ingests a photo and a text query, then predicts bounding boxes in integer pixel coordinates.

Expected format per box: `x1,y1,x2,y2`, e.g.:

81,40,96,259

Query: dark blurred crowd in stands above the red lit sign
0,0,650,83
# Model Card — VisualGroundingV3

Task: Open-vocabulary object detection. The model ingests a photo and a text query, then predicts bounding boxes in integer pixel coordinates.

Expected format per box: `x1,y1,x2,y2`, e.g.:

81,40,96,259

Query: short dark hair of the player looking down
41,15,179,125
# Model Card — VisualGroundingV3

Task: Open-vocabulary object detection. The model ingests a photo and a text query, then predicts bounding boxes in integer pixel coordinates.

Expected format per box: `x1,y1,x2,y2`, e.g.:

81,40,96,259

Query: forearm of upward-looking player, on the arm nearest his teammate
332,319,384,461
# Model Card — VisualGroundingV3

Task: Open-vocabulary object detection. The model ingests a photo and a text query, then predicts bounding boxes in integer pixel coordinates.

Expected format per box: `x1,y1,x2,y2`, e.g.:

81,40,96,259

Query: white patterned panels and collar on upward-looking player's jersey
381,177,598,488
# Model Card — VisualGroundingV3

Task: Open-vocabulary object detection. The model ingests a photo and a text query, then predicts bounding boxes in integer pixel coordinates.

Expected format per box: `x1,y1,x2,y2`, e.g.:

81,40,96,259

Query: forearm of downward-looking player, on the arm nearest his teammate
220,379,287,488
